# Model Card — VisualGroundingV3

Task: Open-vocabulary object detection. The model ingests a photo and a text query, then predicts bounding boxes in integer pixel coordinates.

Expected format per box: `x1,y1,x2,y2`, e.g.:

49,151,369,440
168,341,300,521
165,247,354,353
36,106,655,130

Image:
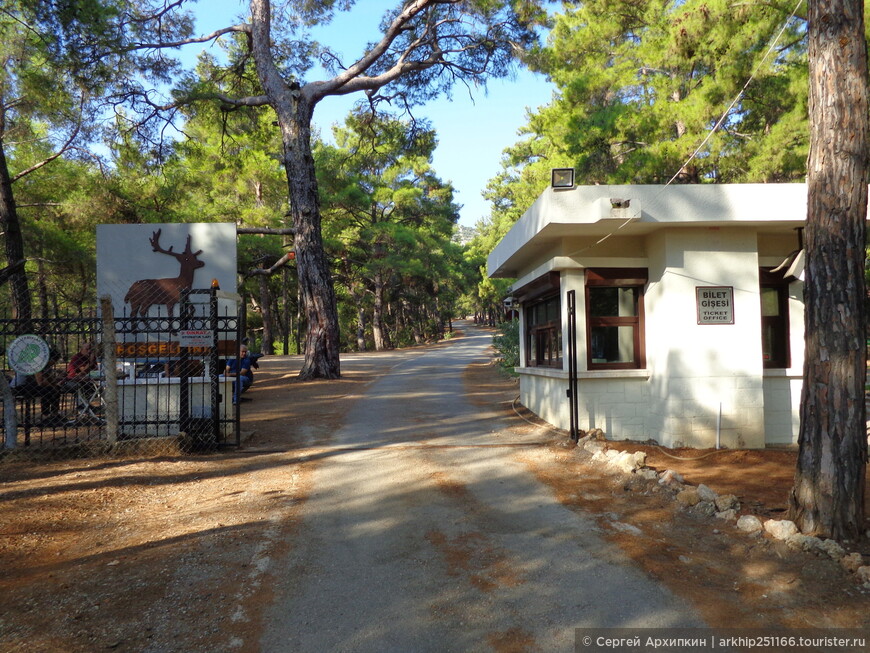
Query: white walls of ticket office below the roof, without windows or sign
519,228,803,448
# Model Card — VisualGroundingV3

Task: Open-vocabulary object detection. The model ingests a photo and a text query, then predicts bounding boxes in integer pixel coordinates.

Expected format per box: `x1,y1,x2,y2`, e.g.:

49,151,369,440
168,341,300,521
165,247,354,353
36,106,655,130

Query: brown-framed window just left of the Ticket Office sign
586,268,648,370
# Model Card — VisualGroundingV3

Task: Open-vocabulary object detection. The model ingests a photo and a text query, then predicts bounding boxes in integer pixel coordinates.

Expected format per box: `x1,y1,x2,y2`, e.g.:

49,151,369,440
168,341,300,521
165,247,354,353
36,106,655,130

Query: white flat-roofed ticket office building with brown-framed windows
488,181,824,448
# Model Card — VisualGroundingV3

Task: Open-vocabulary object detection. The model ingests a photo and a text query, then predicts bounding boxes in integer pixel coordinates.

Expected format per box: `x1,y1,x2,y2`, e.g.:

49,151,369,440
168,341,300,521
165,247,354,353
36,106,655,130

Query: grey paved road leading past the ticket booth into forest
261,329,703,653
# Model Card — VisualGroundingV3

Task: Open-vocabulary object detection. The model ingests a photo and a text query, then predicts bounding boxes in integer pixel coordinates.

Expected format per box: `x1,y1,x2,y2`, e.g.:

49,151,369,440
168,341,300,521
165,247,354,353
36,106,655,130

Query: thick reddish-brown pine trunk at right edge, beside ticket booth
789,0,868,539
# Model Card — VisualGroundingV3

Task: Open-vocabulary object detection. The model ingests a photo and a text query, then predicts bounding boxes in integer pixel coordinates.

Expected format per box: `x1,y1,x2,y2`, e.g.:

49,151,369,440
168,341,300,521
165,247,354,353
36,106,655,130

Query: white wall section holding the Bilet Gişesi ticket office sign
646,228,764,448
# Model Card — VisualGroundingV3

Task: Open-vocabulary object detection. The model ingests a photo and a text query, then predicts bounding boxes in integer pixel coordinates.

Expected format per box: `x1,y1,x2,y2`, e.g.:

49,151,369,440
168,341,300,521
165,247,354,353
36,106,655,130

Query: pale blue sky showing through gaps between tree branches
183,0,554,227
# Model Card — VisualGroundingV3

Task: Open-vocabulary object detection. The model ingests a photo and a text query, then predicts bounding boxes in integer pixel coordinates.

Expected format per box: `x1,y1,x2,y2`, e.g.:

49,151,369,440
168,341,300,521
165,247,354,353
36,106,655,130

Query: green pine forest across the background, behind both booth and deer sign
0,0,848,352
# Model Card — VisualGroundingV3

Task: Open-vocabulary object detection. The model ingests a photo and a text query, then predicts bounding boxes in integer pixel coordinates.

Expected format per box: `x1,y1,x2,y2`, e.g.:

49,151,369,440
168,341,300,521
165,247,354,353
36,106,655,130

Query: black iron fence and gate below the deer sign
0,289,244,458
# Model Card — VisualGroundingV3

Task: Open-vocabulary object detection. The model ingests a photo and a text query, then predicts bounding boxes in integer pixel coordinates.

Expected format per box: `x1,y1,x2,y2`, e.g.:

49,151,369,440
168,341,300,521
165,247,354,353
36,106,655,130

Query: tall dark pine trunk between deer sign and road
251,0,341,379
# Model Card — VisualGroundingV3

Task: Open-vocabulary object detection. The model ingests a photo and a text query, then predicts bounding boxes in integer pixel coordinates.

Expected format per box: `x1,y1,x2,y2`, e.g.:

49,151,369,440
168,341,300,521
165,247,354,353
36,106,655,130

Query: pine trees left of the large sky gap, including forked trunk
0,0,543,356
